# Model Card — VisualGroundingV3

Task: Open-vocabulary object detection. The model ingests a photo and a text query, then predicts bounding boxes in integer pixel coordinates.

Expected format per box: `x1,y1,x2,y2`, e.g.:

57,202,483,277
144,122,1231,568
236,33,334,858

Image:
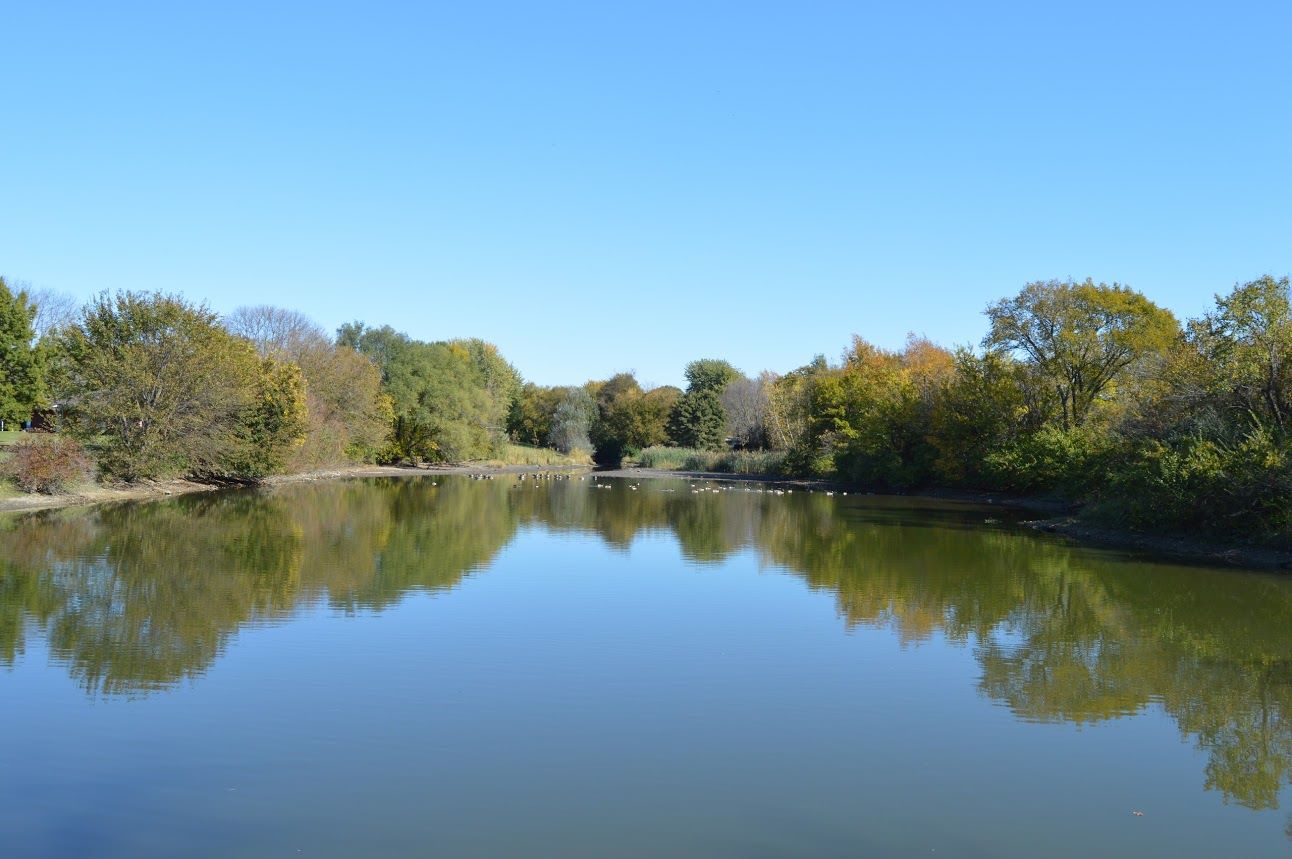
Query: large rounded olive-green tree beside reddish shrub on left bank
57,292,296,479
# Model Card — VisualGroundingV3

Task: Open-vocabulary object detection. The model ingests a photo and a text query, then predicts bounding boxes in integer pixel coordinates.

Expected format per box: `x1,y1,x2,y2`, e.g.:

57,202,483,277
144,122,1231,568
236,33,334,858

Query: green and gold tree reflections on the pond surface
0,479,1292,809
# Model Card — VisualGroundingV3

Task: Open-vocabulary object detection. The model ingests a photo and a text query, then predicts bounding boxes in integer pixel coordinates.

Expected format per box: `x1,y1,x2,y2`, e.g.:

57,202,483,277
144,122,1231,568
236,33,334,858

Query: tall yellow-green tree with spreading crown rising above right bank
983,279,1180,429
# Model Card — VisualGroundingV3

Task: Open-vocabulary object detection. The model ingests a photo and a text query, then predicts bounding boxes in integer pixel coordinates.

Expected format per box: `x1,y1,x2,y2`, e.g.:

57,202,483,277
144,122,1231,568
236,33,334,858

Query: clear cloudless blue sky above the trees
0,0,1292,384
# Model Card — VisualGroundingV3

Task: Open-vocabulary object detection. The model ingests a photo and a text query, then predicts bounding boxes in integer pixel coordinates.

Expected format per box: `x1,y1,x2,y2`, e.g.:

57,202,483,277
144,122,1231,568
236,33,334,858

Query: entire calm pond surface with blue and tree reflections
0,478,1292,859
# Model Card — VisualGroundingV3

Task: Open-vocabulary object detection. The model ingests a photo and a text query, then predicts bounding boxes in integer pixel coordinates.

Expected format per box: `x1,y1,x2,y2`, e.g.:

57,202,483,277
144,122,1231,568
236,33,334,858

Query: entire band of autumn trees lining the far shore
0,276,1292,540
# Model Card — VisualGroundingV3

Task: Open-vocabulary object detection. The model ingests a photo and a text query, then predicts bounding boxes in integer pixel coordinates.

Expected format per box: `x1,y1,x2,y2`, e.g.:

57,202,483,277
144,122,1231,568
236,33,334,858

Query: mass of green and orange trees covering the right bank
766,278,1292,544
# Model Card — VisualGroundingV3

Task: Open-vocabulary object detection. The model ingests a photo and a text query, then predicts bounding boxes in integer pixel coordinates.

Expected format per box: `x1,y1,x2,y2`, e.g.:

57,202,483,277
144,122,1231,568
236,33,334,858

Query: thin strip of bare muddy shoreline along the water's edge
0,462,1292,572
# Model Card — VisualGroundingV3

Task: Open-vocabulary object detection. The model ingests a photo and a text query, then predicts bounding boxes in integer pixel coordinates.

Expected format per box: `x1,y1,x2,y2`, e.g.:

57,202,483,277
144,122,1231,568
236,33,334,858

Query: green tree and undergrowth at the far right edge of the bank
1097,276,1292,545
